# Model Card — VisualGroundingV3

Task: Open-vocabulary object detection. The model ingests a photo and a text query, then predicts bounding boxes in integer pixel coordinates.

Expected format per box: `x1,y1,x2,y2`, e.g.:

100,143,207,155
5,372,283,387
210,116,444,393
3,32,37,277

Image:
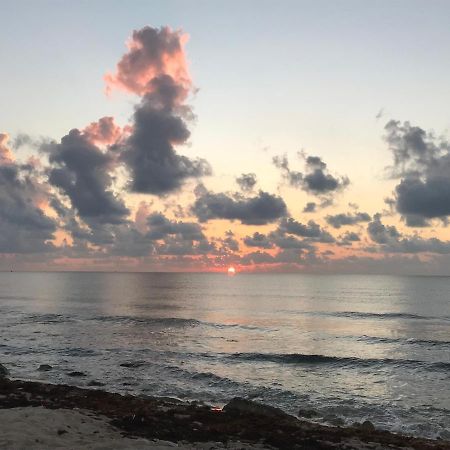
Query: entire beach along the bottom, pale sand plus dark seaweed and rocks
0,370,450,450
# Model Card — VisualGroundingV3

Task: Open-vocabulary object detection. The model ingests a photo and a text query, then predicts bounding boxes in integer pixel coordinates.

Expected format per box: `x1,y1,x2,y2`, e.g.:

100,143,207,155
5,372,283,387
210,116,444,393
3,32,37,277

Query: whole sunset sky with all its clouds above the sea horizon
0,0,450,275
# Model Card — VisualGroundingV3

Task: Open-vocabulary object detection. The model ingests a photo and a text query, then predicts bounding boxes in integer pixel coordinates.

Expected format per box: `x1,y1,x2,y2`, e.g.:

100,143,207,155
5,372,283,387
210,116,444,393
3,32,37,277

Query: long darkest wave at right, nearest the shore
227,353,450,371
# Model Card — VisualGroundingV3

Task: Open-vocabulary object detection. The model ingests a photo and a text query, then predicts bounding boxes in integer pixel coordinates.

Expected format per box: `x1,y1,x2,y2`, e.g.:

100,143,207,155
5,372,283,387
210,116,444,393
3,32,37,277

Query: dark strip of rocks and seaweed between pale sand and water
0,370,450,450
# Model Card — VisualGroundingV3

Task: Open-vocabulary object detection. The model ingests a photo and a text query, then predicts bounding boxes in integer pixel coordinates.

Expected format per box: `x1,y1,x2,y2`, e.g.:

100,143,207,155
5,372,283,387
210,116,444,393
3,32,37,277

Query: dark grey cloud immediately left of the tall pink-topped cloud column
43,129,129,223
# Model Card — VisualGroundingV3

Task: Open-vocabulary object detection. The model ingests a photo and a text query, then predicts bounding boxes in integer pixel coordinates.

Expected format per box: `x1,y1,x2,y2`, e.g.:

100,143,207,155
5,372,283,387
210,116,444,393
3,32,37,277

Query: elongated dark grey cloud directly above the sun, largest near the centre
192,191,287,225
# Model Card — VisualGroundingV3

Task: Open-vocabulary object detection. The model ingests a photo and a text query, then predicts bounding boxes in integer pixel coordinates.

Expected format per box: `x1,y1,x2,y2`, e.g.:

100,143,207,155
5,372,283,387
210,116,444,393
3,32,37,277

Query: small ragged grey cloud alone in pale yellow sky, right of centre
272,152,350,196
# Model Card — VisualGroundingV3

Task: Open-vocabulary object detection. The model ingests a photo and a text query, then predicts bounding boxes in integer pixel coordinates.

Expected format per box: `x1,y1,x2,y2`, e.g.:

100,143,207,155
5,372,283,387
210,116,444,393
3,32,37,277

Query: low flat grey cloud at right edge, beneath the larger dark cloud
367,214,450,254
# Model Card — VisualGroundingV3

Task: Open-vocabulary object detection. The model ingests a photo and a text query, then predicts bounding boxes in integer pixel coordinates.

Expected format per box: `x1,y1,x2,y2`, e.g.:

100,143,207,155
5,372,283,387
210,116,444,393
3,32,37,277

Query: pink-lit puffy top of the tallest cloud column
105,26,191,96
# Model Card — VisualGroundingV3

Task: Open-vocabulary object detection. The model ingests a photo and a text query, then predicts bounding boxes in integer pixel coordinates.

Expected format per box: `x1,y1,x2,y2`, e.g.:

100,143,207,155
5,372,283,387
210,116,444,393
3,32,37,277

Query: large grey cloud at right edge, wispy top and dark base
385,120,450,227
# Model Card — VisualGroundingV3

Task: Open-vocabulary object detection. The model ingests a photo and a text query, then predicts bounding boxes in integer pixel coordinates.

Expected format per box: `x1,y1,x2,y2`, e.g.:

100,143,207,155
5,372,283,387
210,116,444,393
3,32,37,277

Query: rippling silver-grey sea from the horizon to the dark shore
0,273,450,439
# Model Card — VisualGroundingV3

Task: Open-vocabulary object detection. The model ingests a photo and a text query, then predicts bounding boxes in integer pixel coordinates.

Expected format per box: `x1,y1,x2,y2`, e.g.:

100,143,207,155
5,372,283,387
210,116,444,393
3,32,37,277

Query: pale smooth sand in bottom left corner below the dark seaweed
0,407,267,450
